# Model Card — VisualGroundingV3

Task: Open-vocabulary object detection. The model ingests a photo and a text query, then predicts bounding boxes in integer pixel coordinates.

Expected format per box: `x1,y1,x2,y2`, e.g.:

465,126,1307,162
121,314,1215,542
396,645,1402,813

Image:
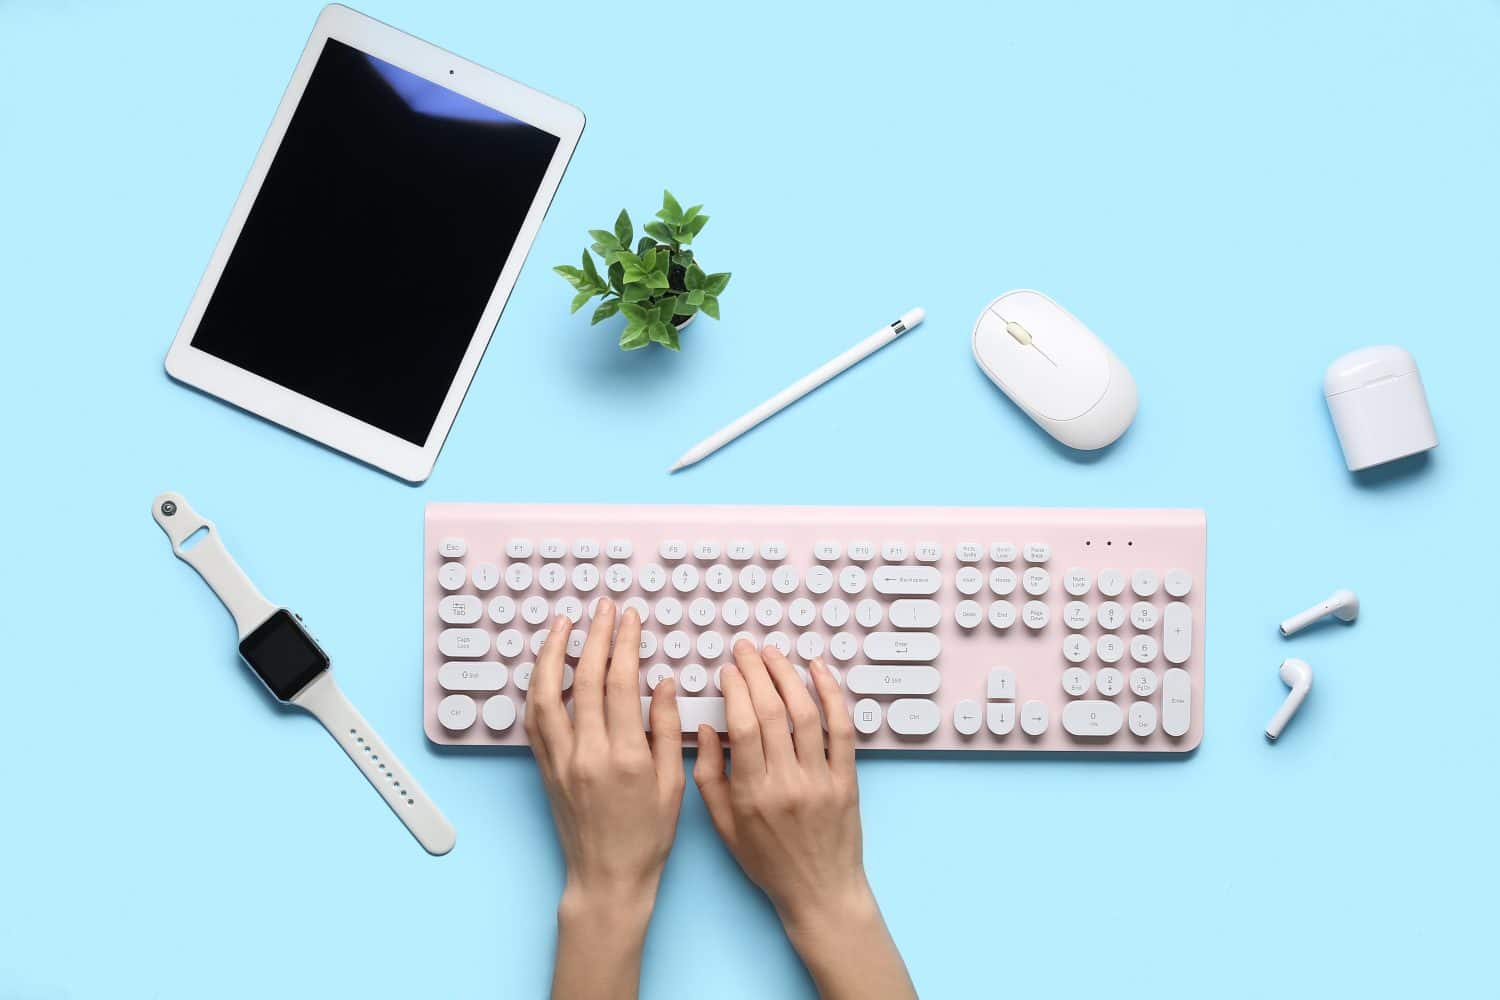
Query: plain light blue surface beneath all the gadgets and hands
0,0,1500,999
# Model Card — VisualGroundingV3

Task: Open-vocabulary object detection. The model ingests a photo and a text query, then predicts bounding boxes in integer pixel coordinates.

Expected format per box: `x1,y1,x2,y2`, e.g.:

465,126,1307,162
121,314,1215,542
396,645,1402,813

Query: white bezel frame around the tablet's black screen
167,4,584,483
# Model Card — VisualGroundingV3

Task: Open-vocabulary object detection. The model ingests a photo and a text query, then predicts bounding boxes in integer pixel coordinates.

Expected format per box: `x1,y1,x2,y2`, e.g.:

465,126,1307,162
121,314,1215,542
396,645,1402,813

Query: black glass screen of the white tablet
192,39,558,445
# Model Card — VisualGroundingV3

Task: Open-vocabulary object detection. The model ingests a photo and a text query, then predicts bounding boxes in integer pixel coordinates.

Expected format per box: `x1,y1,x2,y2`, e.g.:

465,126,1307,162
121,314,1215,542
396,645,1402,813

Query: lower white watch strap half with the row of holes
291,670,455,855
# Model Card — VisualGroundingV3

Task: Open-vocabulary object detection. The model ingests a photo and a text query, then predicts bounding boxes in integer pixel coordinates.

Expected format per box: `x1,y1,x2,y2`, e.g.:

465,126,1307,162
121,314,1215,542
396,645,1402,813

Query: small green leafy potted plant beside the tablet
552,190,729,351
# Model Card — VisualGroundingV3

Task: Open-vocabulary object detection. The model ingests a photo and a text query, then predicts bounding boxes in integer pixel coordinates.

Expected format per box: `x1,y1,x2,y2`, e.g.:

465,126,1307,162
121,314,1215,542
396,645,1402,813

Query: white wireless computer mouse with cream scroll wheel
974,289,1136,451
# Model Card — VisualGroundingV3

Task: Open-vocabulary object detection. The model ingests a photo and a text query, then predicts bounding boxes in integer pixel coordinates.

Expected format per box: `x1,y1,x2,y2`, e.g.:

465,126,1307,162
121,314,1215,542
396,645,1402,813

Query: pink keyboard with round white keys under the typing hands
422,504,1206,753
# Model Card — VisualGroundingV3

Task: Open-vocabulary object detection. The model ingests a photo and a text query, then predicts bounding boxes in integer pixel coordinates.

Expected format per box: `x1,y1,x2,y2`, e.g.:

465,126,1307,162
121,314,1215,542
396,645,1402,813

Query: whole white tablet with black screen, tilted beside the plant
167,4,584,483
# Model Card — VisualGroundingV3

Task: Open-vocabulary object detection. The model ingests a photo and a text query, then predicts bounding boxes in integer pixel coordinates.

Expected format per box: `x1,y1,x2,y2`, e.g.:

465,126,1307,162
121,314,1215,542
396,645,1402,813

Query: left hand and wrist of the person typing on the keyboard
527,597,683,997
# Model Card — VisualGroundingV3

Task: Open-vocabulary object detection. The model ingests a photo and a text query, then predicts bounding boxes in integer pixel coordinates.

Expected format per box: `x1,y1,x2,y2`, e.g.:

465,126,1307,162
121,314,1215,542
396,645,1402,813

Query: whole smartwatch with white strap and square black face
152,493,453,855
